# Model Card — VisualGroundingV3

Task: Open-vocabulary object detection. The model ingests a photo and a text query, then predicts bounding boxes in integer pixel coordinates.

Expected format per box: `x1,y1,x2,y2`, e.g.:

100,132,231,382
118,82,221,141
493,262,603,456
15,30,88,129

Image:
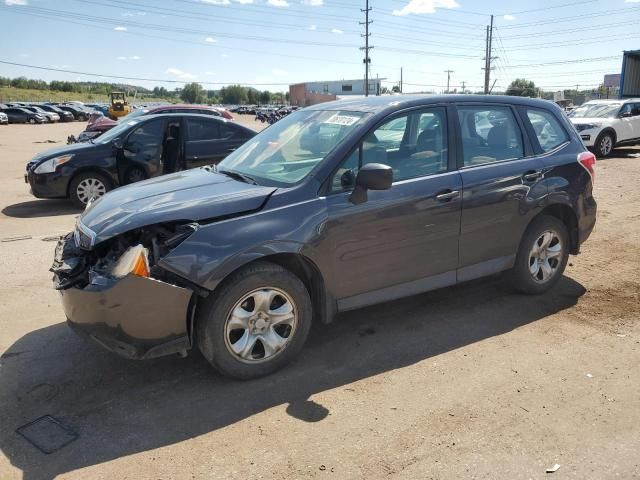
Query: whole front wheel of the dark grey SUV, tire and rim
196,262,312,379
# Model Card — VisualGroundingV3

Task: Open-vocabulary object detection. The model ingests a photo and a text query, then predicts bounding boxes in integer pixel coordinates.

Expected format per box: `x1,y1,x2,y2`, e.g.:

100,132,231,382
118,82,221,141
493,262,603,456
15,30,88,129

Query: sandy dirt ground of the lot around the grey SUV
0,118,640,480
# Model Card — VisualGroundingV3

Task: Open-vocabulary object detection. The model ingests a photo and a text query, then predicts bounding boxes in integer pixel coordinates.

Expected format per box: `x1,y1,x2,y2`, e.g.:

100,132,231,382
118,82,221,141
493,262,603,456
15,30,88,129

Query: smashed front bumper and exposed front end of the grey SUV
51,224,207,359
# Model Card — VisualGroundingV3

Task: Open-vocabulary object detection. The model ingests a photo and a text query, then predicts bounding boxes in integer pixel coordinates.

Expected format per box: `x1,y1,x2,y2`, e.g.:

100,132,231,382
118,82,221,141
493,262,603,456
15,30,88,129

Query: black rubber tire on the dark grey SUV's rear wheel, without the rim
508,215,569,295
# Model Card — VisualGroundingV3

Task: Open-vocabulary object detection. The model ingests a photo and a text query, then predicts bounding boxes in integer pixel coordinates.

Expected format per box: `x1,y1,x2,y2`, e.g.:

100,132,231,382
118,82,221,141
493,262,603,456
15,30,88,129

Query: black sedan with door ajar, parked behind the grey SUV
25,114,255,206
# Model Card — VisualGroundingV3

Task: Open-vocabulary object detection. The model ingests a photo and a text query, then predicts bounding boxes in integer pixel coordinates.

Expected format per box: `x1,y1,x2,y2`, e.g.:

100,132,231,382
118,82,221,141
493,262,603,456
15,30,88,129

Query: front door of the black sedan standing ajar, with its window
117,118,165,185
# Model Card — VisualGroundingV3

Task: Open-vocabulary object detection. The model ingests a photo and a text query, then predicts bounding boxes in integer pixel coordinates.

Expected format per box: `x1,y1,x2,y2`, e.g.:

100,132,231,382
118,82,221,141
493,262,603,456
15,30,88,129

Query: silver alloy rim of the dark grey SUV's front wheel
224,287,298,363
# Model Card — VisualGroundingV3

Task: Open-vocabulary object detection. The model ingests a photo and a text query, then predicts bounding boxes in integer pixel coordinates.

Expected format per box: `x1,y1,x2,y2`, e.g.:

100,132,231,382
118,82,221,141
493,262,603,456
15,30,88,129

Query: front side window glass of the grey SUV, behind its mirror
332,107,448,191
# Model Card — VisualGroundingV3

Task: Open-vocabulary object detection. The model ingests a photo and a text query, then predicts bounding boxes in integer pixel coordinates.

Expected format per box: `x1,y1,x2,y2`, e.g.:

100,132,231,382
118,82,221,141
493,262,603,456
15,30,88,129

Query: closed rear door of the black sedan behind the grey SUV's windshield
185,117,248,168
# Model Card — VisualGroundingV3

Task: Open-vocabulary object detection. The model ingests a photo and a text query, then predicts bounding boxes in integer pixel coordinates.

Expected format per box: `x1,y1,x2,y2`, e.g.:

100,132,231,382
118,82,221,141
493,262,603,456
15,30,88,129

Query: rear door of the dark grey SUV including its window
457,103,546,281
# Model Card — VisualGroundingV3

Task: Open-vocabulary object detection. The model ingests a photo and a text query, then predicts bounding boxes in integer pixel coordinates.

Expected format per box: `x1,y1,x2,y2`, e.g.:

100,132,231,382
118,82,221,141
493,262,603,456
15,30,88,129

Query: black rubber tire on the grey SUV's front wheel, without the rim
196,262,312,380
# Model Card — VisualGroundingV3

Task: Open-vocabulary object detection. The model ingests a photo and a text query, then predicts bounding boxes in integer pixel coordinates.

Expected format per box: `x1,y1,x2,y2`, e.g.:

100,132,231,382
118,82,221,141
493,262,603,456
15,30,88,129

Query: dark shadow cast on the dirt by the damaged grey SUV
0,277,585,480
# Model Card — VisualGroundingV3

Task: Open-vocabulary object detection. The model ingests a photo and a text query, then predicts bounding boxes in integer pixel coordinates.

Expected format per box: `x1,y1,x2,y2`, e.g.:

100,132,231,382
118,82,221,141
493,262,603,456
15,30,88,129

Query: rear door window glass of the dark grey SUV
458,106,524,167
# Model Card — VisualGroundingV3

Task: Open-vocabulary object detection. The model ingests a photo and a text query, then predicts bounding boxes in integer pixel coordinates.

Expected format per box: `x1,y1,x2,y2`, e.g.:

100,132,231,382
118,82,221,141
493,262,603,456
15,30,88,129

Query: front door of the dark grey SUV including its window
324,107,462,310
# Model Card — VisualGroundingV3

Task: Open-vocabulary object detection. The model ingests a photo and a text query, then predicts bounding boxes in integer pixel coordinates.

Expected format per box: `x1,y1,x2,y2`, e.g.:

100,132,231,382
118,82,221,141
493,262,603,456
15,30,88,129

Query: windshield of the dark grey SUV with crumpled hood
218,110,366,185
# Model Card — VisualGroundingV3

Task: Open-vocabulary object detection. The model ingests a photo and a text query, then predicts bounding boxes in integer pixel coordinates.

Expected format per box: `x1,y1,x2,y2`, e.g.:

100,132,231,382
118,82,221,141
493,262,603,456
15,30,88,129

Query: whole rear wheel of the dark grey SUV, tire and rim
509,215,569,295
